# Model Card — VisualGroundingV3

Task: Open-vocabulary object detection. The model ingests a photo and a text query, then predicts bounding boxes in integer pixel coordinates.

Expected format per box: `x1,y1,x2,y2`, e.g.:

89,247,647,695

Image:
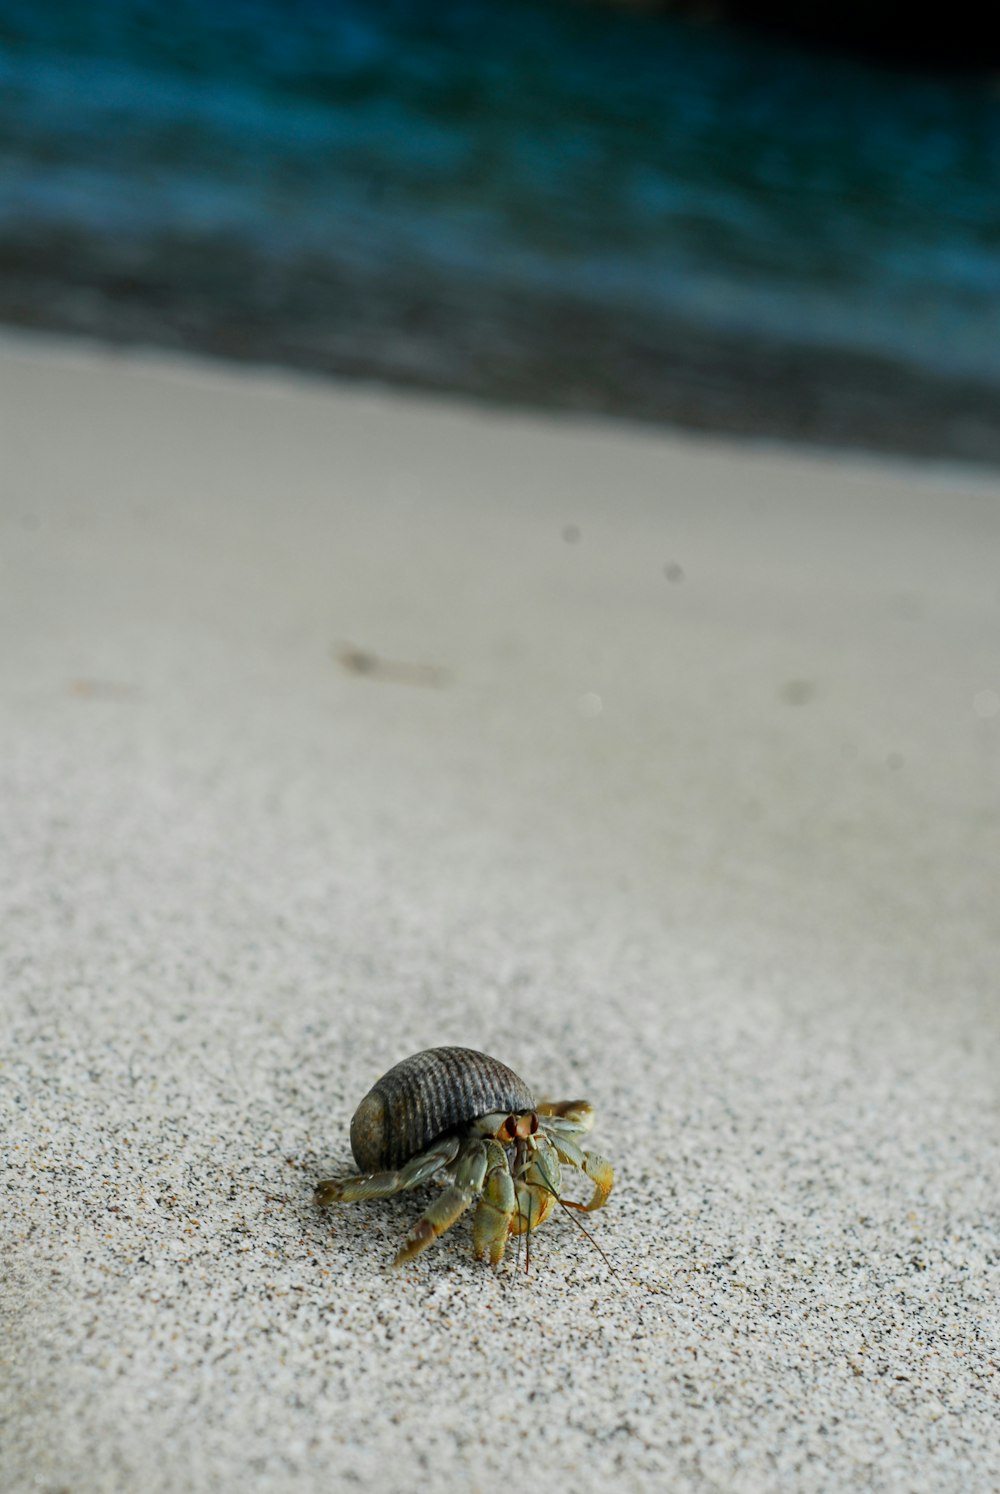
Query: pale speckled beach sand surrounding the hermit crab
0,341,1000,1494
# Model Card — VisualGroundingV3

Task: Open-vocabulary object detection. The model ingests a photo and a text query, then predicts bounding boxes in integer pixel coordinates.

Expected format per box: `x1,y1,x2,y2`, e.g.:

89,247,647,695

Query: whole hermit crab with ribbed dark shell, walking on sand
315,1047,614,1265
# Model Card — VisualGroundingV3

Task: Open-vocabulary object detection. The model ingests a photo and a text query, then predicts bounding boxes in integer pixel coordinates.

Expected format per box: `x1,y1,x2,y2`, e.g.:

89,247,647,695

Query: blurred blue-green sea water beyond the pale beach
0,0,1000,456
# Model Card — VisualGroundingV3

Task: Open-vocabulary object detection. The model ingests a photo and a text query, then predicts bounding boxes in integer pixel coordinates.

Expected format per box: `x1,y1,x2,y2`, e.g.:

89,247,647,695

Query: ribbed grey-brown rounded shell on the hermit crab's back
351,1047,535,1173
